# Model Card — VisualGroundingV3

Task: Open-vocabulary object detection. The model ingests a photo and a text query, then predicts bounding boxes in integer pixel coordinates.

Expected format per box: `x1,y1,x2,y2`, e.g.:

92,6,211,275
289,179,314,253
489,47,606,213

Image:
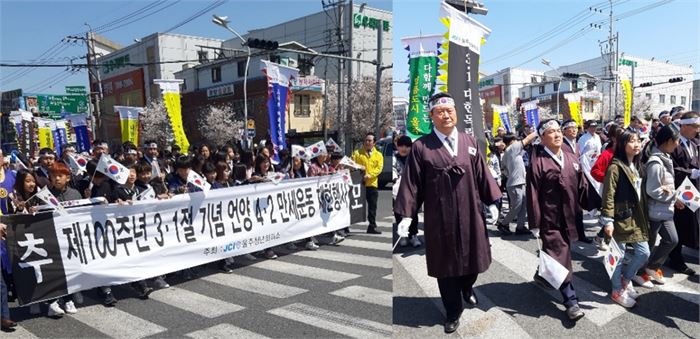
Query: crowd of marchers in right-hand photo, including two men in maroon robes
394,93,700,333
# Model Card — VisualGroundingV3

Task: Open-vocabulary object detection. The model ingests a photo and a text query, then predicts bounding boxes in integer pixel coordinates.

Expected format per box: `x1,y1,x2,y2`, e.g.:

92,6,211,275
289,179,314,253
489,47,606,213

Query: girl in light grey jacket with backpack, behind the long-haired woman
632,125,685,288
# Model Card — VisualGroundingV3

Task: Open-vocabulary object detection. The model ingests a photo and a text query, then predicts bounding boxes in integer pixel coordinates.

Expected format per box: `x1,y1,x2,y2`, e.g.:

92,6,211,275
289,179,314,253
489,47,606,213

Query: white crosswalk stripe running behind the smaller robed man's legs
489,237,627,327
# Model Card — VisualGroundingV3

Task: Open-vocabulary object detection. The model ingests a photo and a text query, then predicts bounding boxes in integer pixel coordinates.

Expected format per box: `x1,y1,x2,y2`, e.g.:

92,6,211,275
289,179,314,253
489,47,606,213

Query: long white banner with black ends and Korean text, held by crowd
1,171,366,304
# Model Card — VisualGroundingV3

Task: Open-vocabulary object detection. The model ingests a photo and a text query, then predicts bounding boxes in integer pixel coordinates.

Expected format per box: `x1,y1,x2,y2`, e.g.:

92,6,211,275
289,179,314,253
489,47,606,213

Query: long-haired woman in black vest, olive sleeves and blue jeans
600,129,649,308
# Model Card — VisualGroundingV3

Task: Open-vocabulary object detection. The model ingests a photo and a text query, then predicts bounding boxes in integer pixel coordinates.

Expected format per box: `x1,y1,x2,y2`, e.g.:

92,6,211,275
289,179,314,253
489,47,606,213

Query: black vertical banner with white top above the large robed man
438,2,491,150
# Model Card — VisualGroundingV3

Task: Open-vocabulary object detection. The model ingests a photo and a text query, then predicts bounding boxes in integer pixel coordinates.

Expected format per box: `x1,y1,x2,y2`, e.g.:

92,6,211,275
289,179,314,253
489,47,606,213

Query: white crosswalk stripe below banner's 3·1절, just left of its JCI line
150,287,245,318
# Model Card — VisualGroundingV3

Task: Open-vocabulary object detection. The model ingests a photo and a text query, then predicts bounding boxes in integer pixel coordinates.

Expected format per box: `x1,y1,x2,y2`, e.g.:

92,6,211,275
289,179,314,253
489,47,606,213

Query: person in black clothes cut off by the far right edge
667,111,700,275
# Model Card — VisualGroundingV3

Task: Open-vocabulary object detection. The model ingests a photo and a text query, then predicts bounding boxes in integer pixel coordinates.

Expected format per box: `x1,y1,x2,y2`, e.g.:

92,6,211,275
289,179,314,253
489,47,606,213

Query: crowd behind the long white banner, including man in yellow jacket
0,133,384,330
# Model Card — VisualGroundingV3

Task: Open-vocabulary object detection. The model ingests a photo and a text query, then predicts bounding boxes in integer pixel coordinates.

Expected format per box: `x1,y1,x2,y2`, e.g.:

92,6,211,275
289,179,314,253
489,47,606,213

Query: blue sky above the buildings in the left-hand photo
0,0,392,94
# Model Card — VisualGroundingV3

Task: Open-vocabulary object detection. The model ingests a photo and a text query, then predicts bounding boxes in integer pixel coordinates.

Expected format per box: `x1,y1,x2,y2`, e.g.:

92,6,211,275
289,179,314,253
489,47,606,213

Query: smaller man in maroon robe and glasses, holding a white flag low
527,119,600,320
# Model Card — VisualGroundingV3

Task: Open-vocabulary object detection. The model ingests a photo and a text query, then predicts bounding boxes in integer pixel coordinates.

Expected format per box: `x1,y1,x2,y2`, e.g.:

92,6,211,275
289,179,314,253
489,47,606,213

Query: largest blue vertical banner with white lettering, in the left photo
260,60,299,162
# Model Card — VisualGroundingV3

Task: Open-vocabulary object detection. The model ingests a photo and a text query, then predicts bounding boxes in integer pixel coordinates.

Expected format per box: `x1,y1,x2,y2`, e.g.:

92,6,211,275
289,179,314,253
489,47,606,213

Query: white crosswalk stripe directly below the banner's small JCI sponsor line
201,273,308,299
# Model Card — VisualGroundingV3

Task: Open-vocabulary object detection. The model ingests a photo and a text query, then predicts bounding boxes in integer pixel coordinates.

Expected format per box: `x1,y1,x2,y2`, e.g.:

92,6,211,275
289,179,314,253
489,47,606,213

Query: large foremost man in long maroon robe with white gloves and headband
394,93,501,333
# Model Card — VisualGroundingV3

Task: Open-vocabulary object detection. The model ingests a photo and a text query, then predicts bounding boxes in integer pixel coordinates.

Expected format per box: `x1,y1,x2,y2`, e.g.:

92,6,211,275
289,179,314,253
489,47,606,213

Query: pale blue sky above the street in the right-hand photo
393,0,700,97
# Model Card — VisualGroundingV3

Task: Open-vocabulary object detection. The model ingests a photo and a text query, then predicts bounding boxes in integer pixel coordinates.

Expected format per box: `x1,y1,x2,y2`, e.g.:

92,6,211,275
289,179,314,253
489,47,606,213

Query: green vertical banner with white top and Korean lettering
401,34,442,140
